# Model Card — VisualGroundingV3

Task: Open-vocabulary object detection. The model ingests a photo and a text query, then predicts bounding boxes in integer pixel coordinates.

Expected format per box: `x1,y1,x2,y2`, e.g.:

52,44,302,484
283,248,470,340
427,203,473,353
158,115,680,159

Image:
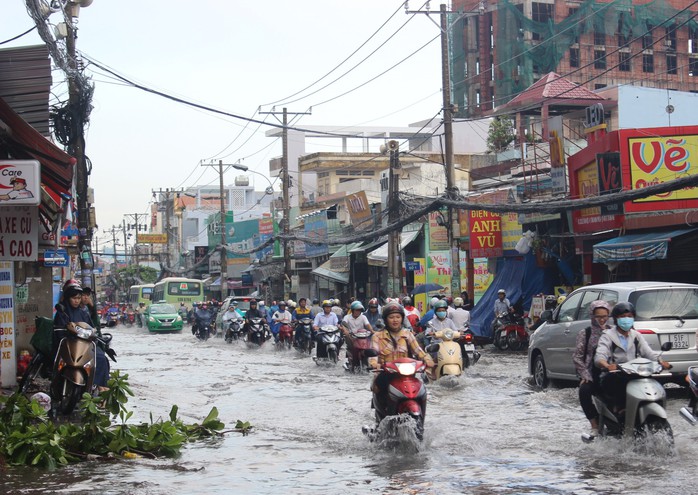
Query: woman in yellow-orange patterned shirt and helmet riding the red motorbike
369,303,434,399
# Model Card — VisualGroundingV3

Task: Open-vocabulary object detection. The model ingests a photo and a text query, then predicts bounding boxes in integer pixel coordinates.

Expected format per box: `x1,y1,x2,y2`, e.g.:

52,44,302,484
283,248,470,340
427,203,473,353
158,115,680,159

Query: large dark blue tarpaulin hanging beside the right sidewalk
470,253,557,338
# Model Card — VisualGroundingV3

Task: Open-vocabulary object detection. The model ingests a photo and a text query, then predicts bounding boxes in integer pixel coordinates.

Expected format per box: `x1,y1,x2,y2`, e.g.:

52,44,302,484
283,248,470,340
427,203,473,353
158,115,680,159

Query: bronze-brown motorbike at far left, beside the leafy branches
51,323,116,414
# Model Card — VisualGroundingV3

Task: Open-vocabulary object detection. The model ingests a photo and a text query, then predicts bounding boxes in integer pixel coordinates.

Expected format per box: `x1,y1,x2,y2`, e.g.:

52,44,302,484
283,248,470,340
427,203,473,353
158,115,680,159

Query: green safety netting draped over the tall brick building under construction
449,0,698,117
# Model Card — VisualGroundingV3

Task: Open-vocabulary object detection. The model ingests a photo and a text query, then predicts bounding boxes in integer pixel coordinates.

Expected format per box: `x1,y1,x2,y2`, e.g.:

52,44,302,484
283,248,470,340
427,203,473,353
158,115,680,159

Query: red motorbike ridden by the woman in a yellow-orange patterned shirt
363,349,427,440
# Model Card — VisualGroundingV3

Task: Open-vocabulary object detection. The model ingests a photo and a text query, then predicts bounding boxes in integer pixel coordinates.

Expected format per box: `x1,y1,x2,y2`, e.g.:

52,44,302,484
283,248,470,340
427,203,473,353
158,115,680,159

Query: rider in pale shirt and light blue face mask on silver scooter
594,302,671,413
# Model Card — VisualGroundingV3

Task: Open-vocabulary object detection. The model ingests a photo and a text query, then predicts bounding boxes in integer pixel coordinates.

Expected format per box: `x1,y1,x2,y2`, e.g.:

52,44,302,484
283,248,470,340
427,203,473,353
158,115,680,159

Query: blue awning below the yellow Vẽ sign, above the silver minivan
594,229,698,263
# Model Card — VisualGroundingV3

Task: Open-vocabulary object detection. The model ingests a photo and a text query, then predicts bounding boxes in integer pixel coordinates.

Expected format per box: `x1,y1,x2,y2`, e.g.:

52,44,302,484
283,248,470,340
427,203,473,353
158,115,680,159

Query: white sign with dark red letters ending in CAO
0,206,39,261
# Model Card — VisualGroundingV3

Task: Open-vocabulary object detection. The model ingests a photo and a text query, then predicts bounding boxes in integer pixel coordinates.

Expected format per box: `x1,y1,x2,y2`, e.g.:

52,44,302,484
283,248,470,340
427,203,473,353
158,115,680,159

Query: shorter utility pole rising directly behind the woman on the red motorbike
387,140,402,297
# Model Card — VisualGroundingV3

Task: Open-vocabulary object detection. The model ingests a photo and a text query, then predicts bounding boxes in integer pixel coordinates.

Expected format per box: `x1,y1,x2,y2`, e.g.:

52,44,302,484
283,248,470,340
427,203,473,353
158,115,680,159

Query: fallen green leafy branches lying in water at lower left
0,370,252,469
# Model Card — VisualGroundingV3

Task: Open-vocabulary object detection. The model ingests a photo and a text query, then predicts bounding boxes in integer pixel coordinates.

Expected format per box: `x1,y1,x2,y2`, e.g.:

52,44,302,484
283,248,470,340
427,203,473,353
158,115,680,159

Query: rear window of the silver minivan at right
630,288,698,321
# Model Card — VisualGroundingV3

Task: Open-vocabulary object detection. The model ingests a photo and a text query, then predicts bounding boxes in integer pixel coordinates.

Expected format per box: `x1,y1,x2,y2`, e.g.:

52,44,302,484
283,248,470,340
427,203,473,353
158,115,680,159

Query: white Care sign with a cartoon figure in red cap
0,160,41,206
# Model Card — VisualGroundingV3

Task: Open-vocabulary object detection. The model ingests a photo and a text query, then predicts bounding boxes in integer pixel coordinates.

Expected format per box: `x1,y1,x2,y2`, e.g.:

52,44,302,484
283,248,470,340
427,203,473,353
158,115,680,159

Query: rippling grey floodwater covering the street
0,327,698,495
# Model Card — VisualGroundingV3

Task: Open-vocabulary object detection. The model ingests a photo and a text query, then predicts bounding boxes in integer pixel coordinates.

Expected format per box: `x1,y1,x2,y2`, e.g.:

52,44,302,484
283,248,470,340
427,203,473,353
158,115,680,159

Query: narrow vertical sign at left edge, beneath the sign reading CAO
0,264,15,387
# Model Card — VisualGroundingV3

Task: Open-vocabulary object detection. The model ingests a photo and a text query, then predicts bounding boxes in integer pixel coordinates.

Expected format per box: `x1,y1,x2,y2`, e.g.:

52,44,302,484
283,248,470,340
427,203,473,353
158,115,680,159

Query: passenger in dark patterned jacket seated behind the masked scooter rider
572,299,611,437
